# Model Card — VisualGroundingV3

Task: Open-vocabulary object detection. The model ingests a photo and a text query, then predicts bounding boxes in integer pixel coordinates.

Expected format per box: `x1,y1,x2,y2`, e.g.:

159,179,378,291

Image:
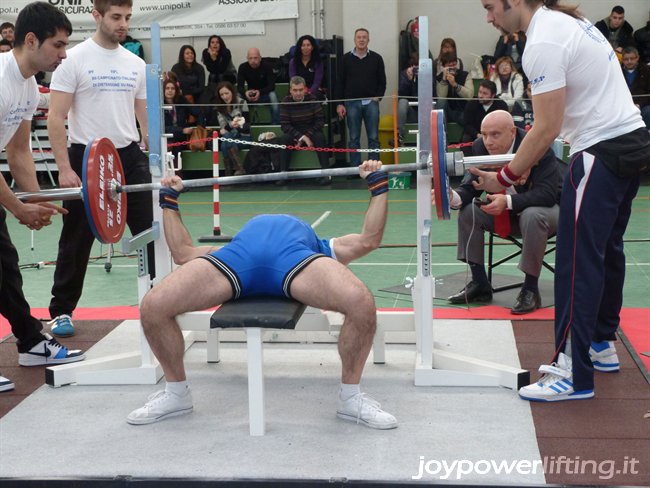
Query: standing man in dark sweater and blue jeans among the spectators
336,28,386,166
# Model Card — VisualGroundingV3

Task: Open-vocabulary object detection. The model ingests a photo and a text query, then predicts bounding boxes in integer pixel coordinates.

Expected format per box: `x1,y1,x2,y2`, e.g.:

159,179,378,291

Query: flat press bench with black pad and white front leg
210,297,307,436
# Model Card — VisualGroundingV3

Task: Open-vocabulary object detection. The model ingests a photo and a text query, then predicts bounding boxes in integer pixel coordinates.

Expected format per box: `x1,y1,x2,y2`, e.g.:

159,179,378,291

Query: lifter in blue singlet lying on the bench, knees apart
127,161,397,429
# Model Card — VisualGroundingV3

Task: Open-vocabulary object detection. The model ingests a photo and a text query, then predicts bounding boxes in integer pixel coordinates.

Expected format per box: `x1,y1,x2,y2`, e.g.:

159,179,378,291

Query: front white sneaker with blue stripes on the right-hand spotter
519,352,594,402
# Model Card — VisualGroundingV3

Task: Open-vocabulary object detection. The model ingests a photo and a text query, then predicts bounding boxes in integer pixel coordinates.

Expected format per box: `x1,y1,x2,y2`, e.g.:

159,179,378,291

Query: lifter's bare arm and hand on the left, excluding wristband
160,176,219,264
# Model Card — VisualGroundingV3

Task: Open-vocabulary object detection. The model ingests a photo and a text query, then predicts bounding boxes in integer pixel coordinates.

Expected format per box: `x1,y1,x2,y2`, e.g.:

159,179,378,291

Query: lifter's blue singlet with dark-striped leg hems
201,215,333,299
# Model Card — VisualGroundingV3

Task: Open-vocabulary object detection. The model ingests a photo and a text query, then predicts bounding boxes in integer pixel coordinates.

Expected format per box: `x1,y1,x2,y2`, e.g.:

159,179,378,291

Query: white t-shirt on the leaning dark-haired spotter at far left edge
0,51,39,151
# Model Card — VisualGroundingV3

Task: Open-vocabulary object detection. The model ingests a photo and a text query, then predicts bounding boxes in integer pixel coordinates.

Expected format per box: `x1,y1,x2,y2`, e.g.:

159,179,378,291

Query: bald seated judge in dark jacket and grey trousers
448,110,564,314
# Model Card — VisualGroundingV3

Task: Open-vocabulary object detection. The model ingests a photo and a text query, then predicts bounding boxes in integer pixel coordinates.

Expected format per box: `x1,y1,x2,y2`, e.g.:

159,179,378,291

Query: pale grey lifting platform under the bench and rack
0,320,545,484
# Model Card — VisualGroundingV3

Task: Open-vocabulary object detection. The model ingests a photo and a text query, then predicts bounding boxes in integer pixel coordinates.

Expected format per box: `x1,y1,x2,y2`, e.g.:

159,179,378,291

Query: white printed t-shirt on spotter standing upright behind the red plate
50,39,147,149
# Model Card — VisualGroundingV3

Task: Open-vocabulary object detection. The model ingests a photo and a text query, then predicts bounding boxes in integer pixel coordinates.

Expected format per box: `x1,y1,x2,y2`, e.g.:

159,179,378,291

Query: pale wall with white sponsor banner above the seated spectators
0,0,649,114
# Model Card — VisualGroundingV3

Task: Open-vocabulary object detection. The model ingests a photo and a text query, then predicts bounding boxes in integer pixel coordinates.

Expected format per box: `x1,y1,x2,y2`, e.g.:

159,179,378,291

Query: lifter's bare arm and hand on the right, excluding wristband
334,160,388,264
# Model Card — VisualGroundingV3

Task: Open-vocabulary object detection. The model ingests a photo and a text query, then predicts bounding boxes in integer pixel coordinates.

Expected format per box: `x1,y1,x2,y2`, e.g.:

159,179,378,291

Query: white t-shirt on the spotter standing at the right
523,7,645,154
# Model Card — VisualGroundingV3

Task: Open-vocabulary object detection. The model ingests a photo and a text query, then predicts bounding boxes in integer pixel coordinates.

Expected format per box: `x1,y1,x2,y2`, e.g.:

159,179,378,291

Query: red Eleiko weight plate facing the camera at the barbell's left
81,137,126,244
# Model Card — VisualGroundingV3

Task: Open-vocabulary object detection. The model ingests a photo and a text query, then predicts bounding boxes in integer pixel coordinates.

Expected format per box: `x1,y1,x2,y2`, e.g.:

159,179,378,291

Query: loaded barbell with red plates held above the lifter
16,117,513,244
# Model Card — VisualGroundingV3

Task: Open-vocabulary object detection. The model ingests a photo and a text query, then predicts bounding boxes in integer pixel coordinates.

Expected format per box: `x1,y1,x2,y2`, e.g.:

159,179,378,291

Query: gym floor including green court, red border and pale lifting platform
0,174,650,486
